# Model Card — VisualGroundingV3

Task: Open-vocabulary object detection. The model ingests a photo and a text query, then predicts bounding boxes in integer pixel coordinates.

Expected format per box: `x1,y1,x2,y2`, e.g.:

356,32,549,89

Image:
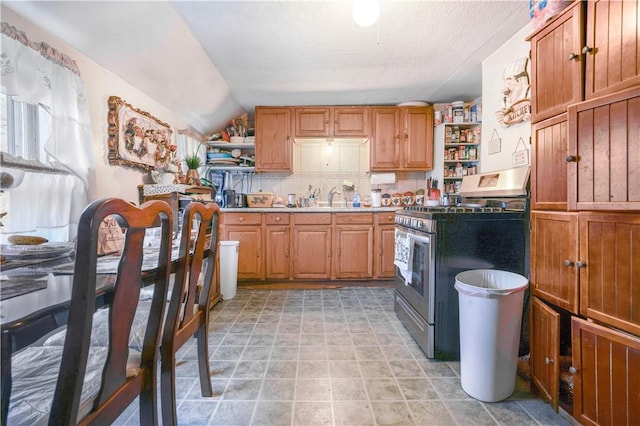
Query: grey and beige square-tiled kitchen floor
117,287,576,426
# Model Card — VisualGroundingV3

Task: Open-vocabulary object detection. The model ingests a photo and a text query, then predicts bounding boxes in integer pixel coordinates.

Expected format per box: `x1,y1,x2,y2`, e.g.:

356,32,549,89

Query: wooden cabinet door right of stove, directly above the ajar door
530,211,581,314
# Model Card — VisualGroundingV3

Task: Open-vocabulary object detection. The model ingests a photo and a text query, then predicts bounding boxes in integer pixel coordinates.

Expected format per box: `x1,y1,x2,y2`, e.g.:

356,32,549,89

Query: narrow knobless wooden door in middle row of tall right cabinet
531,113,568,211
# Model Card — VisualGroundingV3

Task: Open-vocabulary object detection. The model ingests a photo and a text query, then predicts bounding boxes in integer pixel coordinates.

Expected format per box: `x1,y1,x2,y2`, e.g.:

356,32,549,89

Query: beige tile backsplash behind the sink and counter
234,139,426,202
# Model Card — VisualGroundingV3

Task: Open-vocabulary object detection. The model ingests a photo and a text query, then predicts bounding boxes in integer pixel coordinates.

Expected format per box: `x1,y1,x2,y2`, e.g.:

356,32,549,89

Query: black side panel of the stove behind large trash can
435,213,529,360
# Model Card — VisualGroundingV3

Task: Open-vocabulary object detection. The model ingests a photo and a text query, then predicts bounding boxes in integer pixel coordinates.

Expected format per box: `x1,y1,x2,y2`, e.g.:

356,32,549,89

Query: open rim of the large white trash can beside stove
455,269,529,298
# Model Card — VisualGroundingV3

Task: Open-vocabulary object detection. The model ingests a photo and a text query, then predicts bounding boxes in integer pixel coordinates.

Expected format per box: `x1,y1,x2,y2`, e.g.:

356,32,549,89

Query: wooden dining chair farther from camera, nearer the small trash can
160,202,220,425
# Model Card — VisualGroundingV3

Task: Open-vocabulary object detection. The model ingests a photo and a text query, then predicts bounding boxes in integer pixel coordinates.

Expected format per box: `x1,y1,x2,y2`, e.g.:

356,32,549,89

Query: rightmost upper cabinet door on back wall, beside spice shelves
402,106,433,171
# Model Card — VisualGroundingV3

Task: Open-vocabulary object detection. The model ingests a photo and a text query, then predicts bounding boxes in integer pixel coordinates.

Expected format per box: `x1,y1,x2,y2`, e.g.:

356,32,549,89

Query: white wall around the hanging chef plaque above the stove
480,23,534,173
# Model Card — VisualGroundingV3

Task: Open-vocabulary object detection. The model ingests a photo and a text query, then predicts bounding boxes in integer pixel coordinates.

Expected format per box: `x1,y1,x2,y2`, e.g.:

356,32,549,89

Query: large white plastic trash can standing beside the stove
455,269,529,402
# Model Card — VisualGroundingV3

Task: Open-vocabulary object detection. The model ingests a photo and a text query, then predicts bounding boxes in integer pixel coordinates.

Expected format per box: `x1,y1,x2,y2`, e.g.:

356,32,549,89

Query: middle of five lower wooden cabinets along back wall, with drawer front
291,213,333,279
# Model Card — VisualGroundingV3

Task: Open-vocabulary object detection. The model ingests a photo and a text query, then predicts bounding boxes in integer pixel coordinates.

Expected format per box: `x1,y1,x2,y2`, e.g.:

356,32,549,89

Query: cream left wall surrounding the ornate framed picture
0,6,195,203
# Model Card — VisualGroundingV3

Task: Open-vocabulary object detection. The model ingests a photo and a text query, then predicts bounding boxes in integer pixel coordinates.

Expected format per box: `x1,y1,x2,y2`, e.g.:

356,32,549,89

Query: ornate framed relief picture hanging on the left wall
107,96,172,171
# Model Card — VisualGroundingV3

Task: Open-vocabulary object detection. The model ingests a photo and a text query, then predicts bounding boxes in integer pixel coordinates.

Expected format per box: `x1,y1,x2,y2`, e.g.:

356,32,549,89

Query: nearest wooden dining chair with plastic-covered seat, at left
5,198,173,425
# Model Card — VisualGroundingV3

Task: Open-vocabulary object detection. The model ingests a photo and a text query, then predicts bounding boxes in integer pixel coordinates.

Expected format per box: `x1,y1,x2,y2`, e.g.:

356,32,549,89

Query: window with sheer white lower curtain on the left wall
0,93,83,242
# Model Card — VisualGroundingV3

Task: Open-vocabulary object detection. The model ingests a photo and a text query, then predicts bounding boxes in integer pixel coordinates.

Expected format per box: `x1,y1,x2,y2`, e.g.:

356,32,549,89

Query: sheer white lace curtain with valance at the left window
0,22,95,241
